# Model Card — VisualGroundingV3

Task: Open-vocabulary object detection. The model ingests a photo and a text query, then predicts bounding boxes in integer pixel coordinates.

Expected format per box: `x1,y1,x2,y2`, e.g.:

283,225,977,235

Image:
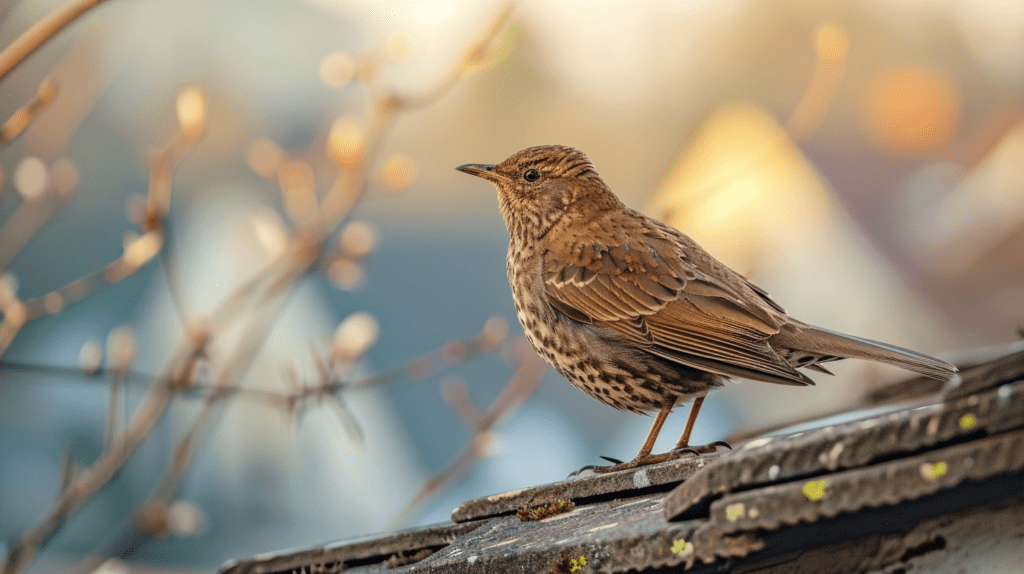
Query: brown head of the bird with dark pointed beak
456,145,618,241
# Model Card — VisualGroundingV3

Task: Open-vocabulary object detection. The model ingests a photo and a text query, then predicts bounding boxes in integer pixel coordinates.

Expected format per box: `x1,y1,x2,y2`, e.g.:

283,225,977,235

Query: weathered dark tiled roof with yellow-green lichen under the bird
222,341,1024,574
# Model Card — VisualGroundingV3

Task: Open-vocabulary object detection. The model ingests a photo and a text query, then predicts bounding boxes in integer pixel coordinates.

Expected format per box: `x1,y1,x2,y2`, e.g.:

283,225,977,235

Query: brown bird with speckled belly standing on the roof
457,145,956,470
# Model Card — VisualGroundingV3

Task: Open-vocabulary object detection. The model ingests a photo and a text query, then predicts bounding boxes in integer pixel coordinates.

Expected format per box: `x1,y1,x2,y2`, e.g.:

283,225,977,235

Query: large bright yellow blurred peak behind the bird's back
651,103,833,273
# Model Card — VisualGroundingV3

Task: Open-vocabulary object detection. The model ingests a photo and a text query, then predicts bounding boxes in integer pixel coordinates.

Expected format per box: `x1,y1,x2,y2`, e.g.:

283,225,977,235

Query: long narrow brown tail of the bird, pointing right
771,324,956,381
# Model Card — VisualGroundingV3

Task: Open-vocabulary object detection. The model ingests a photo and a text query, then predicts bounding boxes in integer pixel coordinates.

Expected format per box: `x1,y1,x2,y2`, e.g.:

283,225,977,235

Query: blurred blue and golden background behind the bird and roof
0,0,1024,572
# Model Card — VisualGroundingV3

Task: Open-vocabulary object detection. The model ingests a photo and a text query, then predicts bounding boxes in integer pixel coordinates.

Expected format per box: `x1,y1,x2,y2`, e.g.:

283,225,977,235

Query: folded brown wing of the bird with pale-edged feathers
544,214,813,385
